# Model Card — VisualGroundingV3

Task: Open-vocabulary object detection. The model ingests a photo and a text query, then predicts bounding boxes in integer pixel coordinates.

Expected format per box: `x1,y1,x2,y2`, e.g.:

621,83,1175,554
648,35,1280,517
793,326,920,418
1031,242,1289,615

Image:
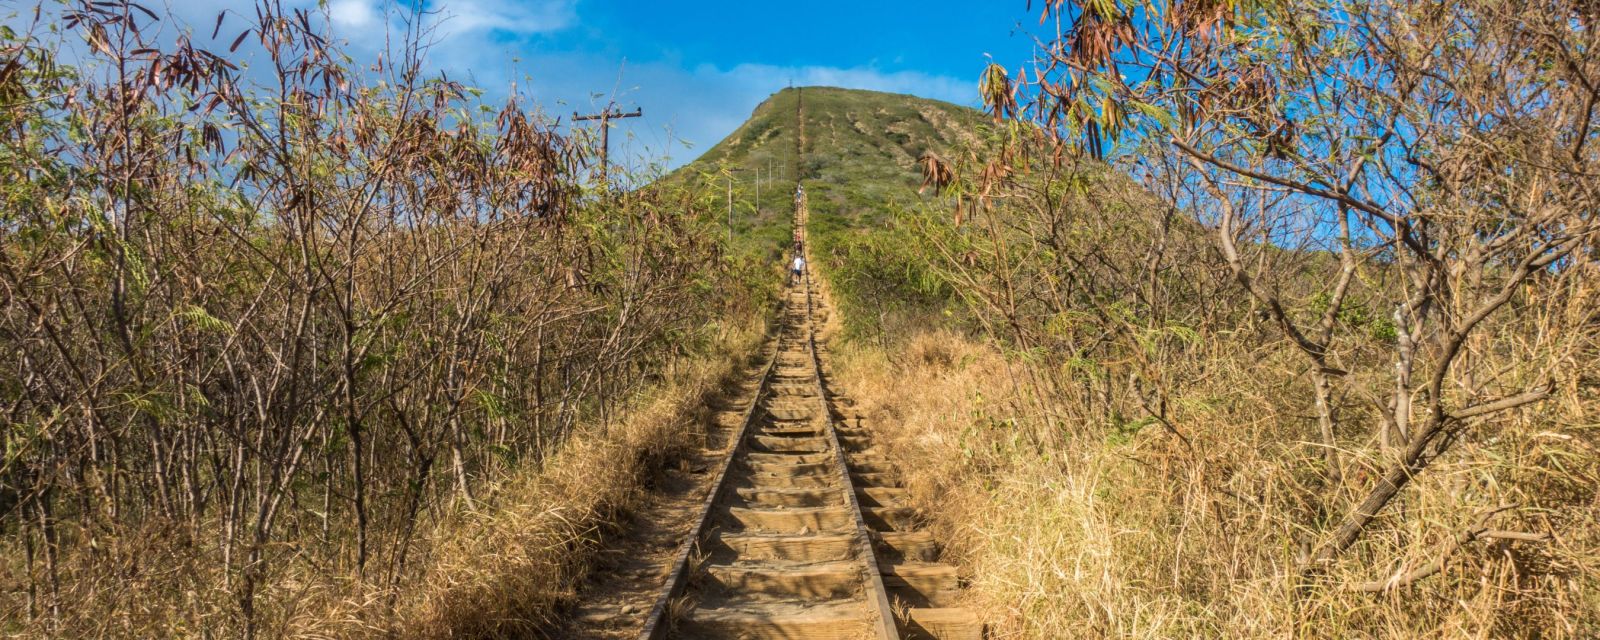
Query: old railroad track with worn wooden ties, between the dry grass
640,276,982,640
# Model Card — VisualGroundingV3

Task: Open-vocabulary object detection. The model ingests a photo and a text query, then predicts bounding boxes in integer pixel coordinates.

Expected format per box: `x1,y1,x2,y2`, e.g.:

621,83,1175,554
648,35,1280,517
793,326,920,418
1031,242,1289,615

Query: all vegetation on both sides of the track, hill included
0,0,1600,640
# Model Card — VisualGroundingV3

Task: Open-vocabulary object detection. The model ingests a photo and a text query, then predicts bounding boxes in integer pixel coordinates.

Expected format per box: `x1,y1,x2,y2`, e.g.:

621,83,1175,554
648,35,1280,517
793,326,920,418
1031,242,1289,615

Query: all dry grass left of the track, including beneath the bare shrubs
0,316,762,638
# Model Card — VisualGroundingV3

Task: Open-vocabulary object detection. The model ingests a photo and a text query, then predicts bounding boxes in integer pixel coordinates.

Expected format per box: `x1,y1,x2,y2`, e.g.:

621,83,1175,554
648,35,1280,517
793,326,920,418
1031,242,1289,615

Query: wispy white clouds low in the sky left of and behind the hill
12,0,976,175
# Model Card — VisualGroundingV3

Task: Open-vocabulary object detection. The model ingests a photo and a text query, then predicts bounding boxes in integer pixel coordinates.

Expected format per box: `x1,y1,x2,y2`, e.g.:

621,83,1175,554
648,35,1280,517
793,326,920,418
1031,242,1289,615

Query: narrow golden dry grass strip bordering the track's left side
385,323,760,638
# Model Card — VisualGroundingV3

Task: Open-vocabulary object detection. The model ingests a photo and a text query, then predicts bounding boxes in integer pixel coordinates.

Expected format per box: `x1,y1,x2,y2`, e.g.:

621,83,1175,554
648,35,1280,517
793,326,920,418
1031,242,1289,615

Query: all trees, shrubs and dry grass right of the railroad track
800,2,1600,638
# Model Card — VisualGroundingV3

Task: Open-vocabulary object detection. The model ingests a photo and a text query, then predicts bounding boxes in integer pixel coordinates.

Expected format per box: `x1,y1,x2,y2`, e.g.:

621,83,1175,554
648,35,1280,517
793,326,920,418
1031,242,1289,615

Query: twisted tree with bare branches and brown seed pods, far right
1004,0,1600,576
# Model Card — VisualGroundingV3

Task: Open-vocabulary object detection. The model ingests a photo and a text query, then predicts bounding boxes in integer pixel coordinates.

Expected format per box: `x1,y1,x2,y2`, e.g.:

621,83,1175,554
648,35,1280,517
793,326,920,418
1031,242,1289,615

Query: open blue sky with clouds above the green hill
265,0,1037,172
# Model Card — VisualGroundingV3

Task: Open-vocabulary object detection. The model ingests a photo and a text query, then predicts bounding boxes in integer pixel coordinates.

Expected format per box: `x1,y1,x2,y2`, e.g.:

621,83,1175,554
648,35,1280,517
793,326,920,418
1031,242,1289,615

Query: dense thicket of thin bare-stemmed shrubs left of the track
0,0,742,637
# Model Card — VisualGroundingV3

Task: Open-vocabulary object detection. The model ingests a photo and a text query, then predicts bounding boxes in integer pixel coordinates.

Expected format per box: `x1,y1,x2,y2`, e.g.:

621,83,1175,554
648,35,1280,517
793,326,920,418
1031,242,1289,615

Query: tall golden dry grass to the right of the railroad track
834,324,1600,638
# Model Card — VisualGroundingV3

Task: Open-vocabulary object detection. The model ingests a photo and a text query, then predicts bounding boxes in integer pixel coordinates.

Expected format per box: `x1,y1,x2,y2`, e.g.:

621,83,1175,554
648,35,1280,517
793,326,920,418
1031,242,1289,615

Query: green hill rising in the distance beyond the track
667,86,986,253
